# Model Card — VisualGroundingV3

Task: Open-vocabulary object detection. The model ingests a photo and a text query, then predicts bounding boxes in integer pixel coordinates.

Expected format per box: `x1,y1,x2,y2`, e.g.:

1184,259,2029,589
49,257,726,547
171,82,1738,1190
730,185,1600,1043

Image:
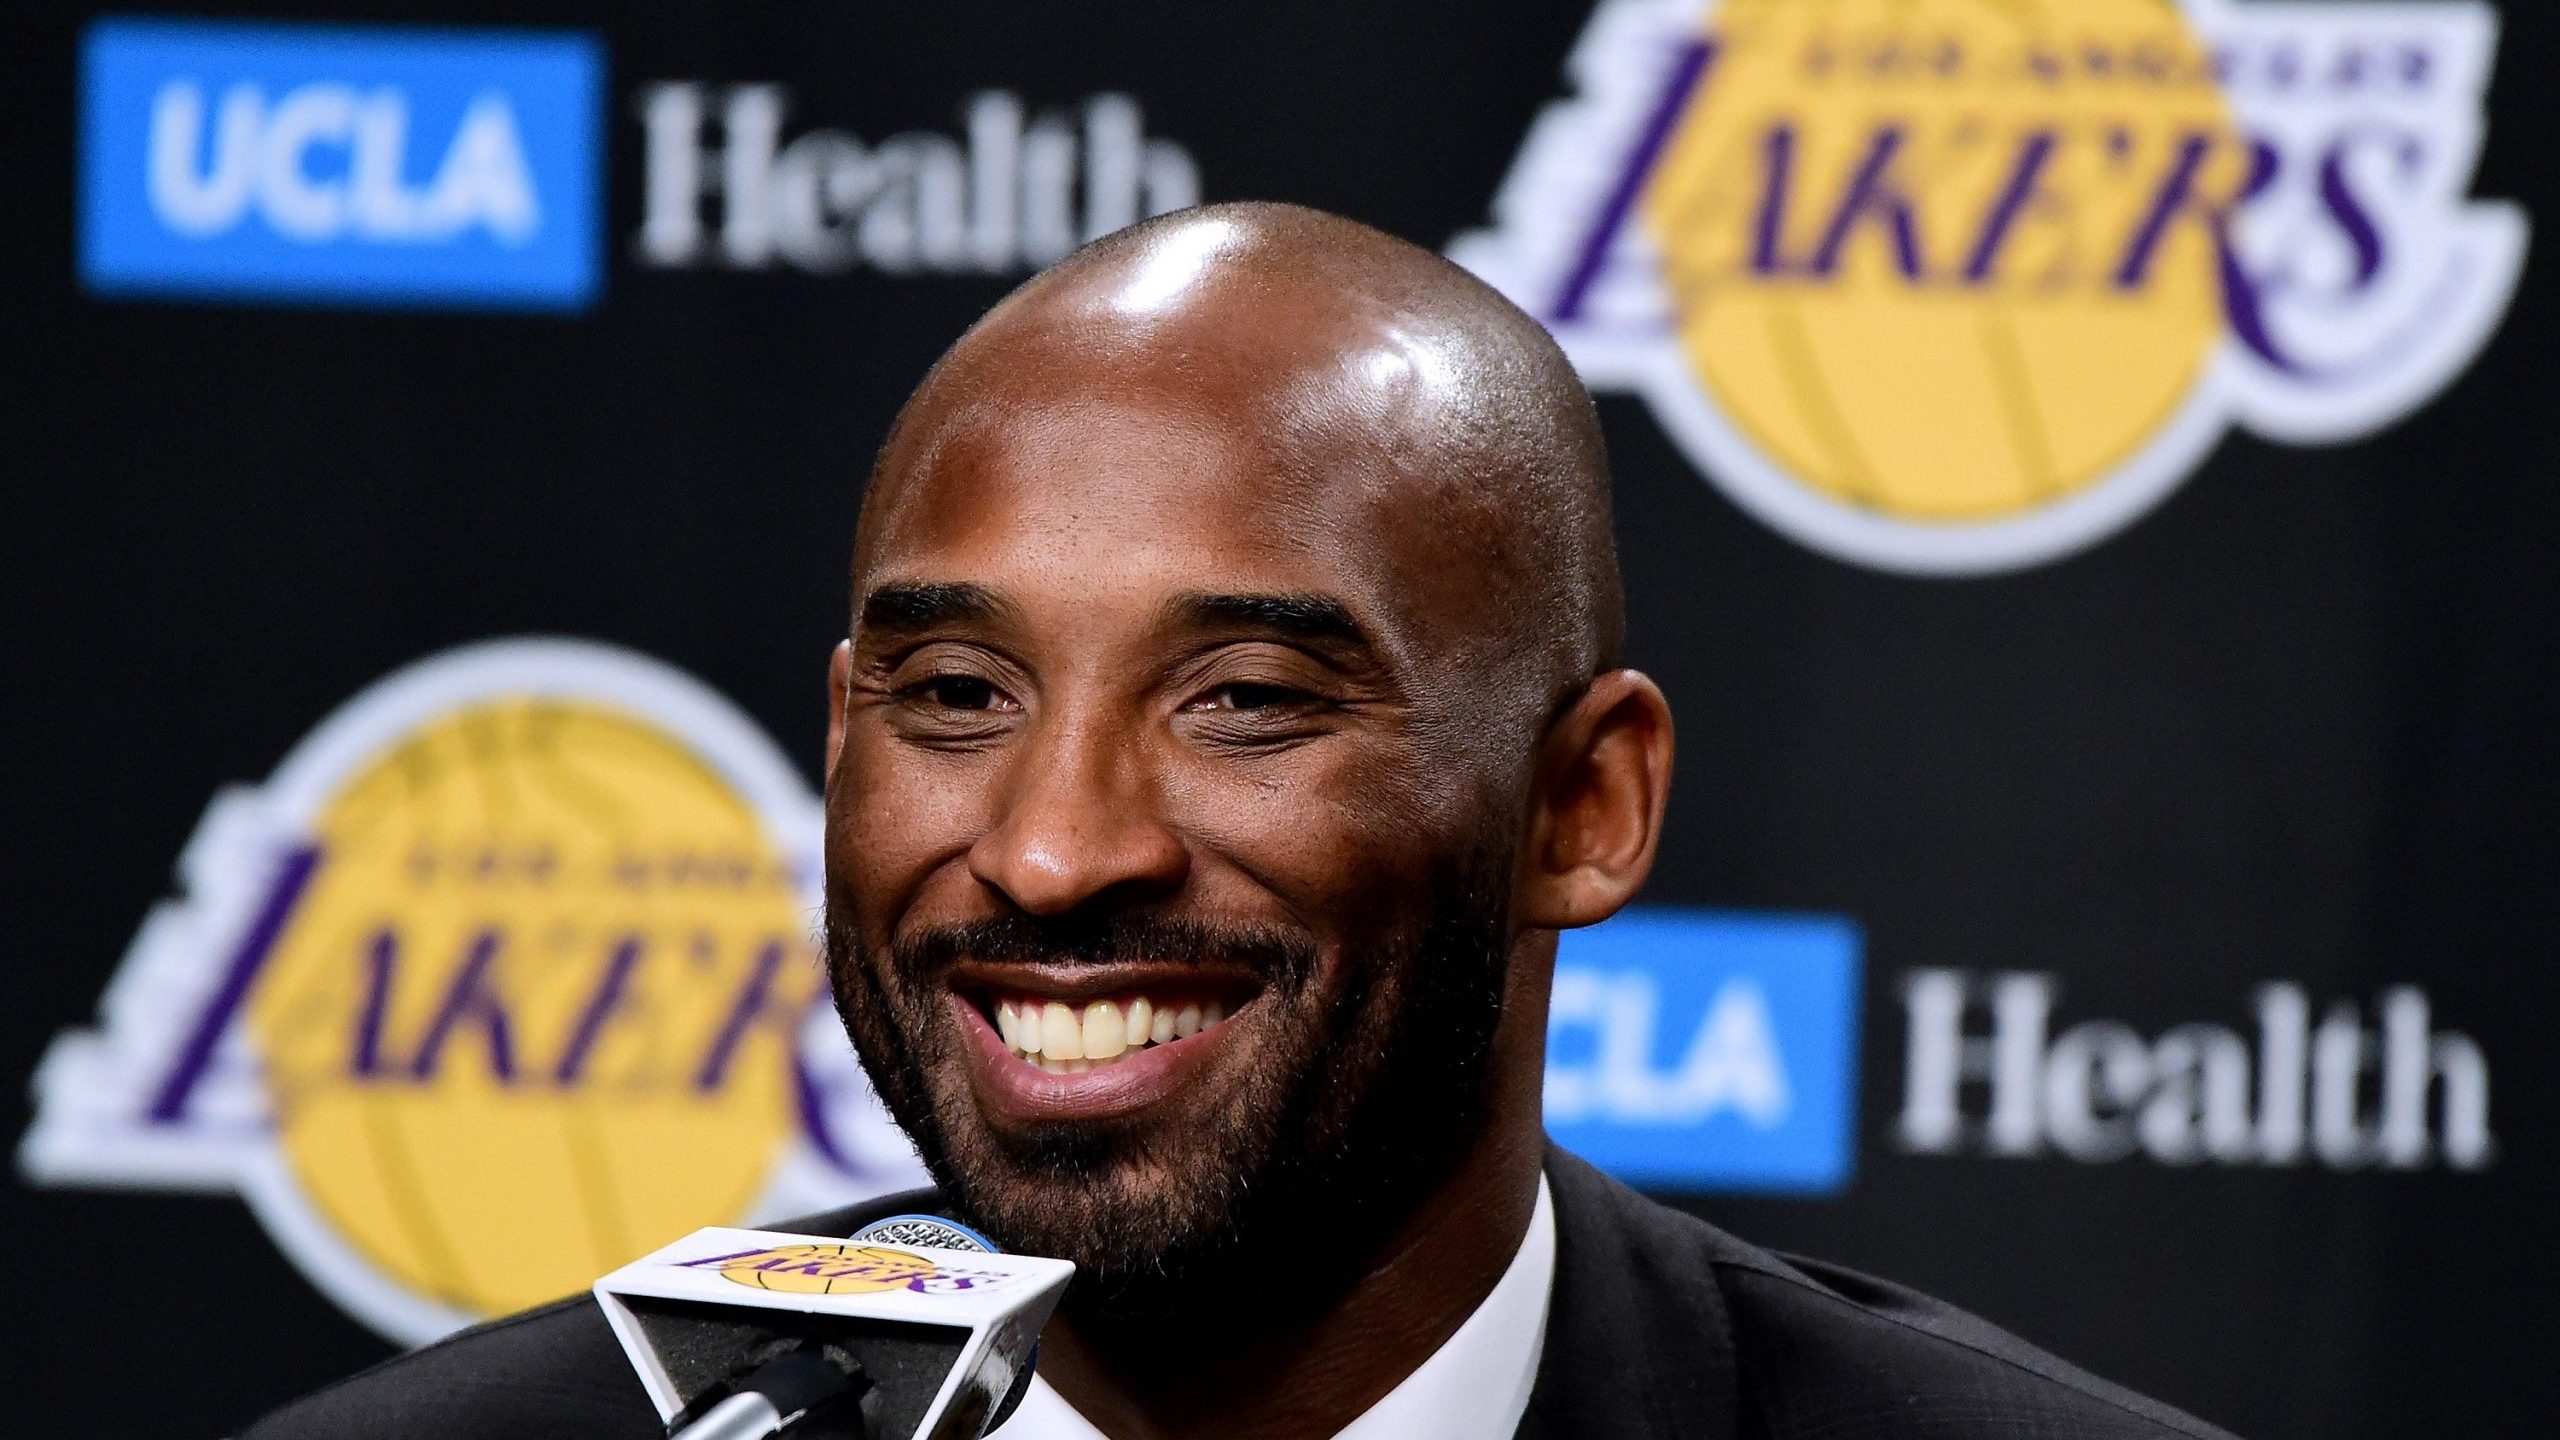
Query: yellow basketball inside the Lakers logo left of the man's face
248,700,812,1314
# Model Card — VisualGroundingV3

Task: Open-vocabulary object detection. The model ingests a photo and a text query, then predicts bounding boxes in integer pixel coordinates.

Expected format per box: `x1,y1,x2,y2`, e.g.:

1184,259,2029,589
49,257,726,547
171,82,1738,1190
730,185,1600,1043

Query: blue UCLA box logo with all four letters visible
79,18,604,310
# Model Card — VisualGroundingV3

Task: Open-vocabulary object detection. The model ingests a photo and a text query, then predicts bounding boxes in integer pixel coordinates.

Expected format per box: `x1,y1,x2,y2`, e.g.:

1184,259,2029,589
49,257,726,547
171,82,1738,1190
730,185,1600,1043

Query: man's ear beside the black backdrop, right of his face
1516,669,1672,930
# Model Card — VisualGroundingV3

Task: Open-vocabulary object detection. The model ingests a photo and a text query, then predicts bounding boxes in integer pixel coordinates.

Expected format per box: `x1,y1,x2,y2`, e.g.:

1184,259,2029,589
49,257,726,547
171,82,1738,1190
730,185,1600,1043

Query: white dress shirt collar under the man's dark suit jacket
988,1176,1556,1440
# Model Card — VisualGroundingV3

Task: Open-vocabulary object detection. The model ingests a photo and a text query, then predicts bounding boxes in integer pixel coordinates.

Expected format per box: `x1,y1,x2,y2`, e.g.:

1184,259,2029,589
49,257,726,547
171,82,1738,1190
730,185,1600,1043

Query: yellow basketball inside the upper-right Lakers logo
1644,0,2248,520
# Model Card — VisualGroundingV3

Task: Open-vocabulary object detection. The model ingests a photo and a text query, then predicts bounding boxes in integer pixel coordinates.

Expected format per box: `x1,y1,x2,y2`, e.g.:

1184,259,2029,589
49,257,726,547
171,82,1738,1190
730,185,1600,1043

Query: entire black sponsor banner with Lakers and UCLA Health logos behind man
15,0,2560,1440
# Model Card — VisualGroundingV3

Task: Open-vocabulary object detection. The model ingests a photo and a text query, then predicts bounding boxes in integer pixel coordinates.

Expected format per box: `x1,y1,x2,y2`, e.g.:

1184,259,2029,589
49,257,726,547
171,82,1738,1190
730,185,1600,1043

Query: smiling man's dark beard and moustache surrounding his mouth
824,853,1510,1327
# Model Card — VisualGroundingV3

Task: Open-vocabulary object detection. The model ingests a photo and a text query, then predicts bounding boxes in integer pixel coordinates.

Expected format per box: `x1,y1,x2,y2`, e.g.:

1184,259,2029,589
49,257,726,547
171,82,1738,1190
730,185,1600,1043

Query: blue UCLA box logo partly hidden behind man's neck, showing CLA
1546,910,1861,1194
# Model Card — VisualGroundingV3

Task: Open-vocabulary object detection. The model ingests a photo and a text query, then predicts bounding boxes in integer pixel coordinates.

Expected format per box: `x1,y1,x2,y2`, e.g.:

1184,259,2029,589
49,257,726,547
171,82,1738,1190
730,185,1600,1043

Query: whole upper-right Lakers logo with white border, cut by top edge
1452,0,2527,574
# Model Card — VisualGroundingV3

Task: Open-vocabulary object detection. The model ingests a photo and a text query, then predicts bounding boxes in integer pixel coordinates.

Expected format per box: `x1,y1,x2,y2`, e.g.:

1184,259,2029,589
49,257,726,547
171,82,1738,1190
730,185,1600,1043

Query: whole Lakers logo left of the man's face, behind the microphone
23,641,931,1340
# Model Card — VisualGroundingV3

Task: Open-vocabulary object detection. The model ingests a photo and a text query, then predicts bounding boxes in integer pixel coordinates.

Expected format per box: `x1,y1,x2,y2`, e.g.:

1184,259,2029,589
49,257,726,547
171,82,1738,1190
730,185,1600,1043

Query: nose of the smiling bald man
968,712,1190,915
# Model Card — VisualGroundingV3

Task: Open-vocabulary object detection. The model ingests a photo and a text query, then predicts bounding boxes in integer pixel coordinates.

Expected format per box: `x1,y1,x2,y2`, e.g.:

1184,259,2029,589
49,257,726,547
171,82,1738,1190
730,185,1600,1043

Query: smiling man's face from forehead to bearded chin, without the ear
827,384,1523,1307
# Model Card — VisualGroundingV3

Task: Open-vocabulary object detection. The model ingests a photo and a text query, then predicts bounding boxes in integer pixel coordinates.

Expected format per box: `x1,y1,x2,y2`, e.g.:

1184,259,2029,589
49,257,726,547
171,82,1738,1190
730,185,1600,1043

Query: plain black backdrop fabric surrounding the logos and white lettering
0,0,2560,1440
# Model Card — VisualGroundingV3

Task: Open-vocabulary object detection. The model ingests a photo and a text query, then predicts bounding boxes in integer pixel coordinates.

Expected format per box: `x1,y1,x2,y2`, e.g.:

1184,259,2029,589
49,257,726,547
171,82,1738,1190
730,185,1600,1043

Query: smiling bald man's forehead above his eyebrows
855,348,1510,661
